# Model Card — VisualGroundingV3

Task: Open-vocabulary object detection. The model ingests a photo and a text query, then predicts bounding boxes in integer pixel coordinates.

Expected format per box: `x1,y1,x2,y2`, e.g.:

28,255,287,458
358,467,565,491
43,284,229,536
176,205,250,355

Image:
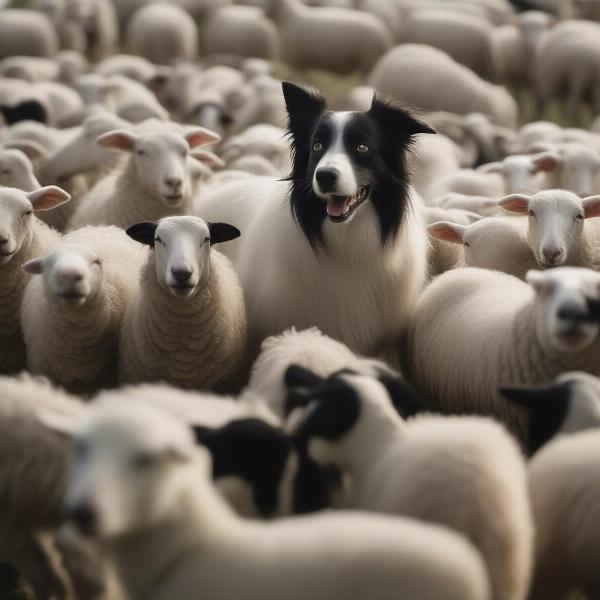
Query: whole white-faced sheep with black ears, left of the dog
119,216,246,390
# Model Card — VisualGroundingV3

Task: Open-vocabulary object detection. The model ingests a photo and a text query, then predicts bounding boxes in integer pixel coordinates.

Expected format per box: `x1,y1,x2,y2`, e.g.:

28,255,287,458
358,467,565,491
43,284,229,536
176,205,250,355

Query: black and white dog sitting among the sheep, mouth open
197,83,435,354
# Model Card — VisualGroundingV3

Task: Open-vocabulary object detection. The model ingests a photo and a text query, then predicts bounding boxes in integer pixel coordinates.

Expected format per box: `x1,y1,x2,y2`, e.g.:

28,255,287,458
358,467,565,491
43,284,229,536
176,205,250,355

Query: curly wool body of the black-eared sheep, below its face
120,249,246,391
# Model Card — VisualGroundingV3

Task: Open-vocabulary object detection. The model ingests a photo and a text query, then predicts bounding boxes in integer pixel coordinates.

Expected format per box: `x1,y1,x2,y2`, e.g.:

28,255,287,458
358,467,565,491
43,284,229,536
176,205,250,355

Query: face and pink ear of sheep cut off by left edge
0,186,70,266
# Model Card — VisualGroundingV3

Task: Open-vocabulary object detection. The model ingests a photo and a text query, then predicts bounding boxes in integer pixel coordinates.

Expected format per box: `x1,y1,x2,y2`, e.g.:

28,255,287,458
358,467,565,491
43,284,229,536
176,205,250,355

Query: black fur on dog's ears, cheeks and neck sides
283,82,435,247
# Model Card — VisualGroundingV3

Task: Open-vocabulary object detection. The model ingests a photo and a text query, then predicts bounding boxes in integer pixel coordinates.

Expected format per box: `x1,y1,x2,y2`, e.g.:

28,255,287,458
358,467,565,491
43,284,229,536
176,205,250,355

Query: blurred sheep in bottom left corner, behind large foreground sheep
0,374,121,598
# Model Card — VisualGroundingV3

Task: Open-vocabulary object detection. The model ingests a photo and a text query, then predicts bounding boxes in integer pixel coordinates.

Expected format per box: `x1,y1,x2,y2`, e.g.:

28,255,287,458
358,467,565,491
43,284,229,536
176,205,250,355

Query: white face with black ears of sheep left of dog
127,216,240,298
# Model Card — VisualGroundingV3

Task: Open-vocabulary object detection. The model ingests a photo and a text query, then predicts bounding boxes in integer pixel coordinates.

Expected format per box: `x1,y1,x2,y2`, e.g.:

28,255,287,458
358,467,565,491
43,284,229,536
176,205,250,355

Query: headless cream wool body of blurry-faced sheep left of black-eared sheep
21,227,147,394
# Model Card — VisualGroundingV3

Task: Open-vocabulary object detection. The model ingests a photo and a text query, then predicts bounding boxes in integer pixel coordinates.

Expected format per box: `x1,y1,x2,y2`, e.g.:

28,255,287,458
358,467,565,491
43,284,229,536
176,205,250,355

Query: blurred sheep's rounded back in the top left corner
0,9,59,58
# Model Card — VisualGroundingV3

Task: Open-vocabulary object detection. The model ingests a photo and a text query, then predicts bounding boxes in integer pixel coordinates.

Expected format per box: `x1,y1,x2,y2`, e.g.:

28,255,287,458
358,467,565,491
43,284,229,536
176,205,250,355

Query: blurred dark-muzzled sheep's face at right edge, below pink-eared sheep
526,267,600,352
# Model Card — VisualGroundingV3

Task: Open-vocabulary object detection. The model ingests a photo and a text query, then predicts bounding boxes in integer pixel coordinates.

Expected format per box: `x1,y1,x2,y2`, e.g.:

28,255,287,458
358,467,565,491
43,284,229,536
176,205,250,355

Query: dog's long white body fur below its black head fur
195,177,427,355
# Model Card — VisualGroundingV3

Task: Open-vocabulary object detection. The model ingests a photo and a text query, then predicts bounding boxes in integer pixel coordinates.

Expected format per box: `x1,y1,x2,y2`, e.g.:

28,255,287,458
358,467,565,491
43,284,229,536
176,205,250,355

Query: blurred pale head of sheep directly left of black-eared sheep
24,244,103,307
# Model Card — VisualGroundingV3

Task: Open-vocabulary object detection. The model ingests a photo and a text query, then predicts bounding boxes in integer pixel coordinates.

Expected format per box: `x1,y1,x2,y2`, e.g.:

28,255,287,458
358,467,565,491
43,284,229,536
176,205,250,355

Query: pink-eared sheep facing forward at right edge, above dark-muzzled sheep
498,190,600,270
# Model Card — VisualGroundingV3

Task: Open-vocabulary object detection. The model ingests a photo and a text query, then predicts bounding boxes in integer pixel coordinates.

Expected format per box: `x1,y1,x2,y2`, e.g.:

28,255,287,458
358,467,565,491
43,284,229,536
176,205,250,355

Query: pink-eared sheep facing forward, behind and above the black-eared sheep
69,128,219,229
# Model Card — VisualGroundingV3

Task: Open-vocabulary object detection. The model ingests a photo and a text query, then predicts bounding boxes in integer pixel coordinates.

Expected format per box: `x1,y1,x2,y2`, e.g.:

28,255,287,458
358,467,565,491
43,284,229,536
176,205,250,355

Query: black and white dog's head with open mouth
283,82,435,245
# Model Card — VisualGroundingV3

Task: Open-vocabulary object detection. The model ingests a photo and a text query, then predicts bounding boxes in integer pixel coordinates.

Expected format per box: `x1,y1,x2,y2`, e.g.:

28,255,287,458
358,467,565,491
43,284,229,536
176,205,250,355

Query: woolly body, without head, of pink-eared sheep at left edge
0,195,60,373
